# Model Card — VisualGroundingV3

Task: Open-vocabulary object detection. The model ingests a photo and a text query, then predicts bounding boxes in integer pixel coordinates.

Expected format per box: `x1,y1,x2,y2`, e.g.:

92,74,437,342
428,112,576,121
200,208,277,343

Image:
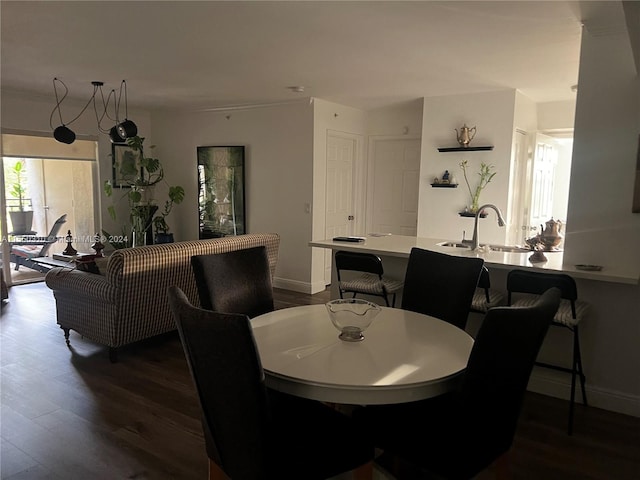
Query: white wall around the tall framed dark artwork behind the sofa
152,101,313,291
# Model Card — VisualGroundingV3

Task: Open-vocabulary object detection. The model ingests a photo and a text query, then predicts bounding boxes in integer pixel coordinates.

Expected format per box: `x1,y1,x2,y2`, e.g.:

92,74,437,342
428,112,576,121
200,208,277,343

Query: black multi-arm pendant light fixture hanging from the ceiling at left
49,78,138,144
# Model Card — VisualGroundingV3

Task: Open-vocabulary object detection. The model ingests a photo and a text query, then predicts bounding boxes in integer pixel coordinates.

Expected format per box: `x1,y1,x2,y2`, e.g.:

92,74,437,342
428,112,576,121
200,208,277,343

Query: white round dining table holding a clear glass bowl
251,305,473,405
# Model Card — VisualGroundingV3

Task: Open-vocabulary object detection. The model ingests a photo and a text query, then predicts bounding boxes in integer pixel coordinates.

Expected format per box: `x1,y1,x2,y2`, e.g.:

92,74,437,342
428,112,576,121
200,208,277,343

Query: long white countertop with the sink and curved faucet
309,235,639,285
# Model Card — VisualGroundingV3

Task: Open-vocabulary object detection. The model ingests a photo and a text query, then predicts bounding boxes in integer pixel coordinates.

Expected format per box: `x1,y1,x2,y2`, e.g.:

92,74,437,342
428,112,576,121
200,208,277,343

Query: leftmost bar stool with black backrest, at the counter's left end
335,250,404,307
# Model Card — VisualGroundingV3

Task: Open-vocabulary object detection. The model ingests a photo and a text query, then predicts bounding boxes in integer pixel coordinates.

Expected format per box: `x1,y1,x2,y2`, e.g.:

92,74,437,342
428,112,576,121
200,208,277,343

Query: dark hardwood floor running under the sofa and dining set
0,283,640,480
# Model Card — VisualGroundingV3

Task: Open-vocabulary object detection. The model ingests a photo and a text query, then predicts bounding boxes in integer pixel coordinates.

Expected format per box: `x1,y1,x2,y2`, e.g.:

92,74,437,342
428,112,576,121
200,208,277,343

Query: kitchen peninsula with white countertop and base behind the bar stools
309,235,640,416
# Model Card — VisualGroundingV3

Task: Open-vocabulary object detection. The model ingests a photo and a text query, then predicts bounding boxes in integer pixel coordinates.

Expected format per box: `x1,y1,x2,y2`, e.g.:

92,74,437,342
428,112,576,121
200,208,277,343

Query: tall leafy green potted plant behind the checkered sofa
103,136,184,248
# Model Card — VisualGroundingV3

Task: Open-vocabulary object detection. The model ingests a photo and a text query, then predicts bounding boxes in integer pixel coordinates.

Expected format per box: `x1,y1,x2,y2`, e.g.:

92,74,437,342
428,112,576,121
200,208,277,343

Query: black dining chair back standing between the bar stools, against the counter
402,247,484,329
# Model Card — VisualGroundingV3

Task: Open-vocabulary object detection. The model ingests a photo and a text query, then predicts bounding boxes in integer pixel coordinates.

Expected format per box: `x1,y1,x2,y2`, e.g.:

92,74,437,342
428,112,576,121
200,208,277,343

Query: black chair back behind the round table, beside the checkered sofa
191,246,274,318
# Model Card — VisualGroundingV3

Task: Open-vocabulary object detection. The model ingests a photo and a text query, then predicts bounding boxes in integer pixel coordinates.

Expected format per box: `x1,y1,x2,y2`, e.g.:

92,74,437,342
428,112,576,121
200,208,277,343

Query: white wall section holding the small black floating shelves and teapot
418,90,516,243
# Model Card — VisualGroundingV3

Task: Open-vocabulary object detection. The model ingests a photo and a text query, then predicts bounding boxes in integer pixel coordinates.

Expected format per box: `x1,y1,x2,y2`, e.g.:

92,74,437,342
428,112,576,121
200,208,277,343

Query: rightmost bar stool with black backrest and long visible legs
507,270,588,435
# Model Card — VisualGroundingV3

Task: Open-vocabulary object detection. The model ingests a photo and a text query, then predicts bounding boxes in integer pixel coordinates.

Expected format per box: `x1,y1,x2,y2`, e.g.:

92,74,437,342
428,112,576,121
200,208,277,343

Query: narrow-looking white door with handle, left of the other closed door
325,132,357,285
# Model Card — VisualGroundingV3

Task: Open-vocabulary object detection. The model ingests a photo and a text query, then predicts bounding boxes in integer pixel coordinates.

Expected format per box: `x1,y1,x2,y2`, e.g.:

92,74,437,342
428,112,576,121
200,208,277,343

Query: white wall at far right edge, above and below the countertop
552,23,640,416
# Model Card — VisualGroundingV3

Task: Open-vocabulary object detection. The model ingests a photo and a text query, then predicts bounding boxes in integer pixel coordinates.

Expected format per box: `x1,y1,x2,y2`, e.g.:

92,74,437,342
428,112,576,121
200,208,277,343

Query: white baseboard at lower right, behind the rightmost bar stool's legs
527,367,640,417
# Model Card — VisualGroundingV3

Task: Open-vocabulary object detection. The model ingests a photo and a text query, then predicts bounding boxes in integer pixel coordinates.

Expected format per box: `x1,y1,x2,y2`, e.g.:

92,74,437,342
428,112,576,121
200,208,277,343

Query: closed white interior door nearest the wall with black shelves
367,139,420,236
